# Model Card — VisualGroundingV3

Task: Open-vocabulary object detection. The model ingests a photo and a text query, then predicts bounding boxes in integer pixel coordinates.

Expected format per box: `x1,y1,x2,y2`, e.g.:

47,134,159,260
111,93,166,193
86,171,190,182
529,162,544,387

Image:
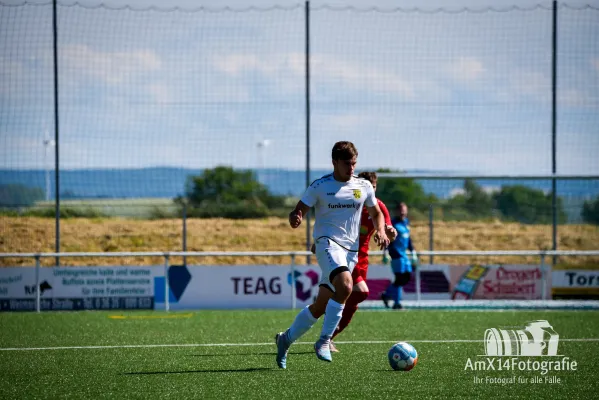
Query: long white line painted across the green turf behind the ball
0,338,599,351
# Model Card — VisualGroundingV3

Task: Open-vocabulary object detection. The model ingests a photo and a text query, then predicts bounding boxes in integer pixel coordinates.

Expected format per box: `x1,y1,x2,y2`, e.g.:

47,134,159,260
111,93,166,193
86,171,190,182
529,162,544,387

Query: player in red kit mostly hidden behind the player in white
330,172,397,352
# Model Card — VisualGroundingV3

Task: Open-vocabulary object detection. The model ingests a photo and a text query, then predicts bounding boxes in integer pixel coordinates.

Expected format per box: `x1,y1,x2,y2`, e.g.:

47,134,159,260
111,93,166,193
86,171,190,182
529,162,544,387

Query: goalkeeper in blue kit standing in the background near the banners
381,202,418,309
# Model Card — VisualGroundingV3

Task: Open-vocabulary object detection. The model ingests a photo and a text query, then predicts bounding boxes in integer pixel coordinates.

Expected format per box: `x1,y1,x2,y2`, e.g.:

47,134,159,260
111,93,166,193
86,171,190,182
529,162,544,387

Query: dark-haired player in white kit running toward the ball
275,141,389,368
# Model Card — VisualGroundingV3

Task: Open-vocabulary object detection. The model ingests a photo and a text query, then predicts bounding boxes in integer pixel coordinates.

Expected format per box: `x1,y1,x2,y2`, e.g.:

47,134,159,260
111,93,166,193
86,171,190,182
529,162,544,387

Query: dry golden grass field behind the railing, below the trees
0,217,599,266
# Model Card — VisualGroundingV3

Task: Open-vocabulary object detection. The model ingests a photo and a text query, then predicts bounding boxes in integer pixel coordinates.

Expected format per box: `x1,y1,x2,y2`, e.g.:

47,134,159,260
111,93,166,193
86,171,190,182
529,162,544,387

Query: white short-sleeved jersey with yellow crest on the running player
301,174,377,251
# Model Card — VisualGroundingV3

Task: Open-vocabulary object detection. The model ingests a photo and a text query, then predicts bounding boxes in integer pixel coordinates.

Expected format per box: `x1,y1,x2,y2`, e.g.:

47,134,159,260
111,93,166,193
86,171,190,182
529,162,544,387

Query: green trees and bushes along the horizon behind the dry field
0,166,599,225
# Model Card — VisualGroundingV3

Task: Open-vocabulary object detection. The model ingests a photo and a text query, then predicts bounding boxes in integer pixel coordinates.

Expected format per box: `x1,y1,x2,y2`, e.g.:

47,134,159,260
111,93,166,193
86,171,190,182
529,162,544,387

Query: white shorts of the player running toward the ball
316,237,358,292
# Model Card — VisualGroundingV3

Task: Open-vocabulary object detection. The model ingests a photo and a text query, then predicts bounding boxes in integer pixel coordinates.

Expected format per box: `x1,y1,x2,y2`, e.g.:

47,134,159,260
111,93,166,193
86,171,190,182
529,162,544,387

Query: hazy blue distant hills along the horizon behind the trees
0,167,599,222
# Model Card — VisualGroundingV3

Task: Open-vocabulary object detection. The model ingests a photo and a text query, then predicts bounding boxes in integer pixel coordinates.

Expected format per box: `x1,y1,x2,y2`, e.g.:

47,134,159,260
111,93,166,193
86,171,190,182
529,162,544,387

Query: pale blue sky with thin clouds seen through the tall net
0,0,599,174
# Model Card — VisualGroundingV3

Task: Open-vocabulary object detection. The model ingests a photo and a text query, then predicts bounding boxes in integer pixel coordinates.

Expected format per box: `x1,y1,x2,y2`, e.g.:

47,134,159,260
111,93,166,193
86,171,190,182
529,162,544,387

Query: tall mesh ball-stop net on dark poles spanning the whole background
0,3,599,266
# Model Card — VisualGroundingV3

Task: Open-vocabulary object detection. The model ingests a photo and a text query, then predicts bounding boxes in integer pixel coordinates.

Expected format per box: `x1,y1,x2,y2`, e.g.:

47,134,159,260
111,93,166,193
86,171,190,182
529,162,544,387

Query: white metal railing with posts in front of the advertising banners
0,250,599,312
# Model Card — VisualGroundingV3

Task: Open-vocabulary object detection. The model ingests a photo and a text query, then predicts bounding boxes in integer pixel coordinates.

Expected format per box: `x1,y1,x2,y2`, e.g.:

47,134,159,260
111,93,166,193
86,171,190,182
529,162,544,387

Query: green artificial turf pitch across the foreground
0,310,599,399
